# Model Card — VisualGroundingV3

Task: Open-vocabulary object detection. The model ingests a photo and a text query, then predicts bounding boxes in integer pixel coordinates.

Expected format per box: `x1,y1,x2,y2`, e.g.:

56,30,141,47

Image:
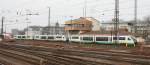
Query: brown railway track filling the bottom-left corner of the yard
0,49,40,65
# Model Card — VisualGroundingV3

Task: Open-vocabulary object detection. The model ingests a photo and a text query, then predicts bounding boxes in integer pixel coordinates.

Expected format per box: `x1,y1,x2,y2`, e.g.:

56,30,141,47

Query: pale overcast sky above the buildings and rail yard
0,0,150,32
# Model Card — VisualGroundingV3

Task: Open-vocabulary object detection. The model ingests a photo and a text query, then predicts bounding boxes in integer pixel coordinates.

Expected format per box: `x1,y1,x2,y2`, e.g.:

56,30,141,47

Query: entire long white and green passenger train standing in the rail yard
14,35,137,44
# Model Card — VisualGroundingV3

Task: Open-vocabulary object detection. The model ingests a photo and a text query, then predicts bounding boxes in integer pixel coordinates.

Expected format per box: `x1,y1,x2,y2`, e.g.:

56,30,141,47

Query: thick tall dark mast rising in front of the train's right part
114,0,119,44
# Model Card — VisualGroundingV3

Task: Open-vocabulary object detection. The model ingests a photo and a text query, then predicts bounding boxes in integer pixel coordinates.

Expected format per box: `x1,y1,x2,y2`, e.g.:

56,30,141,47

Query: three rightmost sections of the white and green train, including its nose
80,35,137,44
